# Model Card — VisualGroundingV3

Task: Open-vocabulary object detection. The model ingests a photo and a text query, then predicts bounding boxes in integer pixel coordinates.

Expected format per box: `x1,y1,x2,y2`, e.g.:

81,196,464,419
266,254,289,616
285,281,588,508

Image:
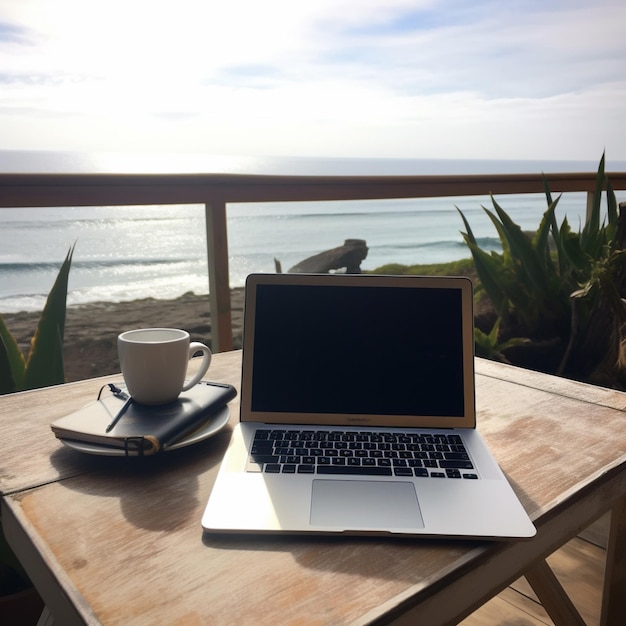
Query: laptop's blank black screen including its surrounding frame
242,274,473,426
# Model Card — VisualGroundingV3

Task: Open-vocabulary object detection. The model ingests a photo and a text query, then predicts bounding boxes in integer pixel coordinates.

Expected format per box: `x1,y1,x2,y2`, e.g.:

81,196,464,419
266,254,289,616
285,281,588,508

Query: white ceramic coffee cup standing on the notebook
117,328,211,404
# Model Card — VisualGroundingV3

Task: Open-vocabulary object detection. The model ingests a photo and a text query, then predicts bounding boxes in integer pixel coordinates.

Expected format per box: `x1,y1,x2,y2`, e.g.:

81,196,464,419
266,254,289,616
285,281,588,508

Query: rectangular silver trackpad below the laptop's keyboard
311,480,424,530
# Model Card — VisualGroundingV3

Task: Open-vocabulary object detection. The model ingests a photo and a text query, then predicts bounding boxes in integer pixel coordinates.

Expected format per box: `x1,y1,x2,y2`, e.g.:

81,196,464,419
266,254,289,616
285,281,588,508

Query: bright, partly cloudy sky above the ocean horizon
0,0,626,163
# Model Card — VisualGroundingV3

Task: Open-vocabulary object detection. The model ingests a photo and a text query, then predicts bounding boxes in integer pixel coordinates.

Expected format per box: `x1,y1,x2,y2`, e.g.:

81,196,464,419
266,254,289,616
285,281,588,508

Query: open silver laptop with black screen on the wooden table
202,274,535,539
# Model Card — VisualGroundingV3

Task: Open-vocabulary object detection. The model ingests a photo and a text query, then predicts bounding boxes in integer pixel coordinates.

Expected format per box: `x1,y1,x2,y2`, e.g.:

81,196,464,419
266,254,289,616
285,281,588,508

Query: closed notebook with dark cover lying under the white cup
50,381,237,455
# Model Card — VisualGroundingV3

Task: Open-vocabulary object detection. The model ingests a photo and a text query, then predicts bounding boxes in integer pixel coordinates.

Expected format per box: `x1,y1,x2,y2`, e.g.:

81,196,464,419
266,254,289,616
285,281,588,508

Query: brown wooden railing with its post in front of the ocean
0,172,626,351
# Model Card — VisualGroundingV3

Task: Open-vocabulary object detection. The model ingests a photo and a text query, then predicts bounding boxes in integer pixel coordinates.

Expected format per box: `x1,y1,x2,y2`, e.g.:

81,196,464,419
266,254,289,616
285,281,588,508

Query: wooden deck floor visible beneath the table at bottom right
461,520,607,626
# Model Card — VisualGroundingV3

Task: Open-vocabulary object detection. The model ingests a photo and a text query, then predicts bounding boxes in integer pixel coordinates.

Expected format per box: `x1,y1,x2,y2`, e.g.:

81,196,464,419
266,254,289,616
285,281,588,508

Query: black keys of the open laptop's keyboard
247,428,478,479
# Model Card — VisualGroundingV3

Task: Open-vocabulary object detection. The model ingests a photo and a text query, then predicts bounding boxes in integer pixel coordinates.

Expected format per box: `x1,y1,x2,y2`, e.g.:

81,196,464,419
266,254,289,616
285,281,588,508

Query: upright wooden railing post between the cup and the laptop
205,199,233,352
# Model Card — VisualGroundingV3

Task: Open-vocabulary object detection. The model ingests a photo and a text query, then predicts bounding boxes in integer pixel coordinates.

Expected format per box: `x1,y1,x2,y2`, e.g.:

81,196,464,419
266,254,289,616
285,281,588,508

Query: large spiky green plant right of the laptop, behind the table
457,155,626,373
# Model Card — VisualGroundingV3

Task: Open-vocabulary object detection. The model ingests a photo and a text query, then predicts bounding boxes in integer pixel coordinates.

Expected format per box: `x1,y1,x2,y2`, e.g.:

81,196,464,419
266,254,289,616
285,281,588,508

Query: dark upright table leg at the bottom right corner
600,500,626,626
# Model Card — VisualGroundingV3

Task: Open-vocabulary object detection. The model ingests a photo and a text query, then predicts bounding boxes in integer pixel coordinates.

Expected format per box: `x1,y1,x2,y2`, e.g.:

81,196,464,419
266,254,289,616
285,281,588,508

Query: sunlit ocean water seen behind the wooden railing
0,151,626,313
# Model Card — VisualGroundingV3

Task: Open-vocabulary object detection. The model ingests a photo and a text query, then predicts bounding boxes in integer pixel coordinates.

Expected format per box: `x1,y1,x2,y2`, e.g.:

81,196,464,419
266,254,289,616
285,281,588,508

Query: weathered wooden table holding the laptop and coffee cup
0,352,626,626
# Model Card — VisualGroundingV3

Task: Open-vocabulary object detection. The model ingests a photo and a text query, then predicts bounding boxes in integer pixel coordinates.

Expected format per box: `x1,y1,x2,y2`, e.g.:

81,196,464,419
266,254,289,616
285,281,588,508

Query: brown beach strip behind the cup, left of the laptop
2,288,243,382
